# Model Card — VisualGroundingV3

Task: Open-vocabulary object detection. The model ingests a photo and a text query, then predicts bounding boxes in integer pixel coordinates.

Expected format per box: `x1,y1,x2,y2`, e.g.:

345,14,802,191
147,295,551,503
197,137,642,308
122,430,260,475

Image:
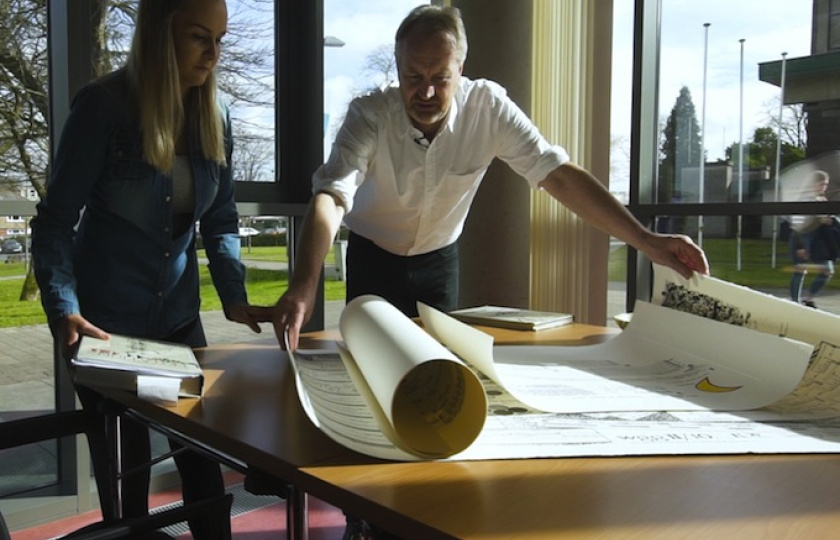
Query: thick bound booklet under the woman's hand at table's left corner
70,334,204,397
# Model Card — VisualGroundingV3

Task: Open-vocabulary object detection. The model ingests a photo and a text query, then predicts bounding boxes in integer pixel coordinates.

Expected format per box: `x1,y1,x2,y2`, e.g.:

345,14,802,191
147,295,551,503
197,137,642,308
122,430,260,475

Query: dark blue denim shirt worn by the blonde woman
32,70,247,338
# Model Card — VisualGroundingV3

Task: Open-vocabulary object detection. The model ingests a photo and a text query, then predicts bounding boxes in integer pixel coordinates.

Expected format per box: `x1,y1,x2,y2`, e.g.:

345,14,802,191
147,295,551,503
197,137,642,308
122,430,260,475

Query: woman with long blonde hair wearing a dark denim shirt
32,0,270,540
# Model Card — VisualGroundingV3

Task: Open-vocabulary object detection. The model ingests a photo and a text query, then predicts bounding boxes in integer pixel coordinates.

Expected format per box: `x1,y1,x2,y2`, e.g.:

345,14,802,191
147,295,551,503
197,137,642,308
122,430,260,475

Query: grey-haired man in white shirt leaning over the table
273,5,708,349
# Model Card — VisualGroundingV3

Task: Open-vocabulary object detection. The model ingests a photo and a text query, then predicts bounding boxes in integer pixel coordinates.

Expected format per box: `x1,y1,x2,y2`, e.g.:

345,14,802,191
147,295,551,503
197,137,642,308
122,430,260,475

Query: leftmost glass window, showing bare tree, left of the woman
0,0,59,502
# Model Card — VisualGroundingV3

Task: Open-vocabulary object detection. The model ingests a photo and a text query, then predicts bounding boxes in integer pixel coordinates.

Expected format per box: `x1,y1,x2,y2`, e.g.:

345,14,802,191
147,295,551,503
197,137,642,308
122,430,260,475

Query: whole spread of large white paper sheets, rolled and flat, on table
292,278,840,460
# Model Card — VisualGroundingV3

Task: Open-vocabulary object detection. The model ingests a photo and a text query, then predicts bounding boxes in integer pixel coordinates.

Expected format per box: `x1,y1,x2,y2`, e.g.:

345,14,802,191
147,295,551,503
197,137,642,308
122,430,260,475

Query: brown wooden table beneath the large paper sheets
93,324,840,540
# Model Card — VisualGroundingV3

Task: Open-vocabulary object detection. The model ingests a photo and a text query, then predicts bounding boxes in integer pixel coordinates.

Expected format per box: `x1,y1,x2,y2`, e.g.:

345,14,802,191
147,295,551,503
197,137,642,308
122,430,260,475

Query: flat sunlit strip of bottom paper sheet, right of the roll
450,343,840,460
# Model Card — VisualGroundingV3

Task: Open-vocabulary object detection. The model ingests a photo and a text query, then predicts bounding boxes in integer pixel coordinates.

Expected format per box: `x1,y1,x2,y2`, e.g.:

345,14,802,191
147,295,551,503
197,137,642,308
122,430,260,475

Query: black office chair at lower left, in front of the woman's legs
0,410,233,540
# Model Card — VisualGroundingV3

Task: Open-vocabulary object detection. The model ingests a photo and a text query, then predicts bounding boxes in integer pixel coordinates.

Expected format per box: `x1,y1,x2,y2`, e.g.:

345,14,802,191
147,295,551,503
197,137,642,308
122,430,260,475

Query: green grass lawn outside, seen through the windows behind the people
0,240,840,328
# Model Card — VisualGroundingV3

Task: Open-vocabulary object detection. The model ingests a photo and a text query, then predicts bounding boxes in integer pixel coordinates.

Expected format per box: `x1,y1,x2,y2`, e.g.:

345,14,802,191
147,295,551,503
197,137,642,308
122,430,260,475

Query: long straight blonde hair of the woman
125,0,226,173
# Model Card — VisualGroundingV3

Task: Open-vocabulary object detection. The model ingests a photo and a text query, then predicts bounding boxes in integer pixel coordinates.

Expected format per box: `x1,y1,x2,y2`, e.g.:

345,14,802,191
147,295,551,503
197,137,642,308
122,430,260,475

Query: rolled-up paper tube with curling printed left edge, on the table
288,296,487,458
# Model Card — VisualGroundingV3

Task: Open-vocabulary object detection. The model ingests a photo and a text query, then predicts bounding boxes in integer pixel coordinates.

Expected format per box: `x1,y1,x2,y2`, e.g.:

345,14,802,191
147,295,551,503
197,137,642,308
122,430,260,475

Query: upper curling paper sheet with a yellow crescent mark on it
423,302,812,413
